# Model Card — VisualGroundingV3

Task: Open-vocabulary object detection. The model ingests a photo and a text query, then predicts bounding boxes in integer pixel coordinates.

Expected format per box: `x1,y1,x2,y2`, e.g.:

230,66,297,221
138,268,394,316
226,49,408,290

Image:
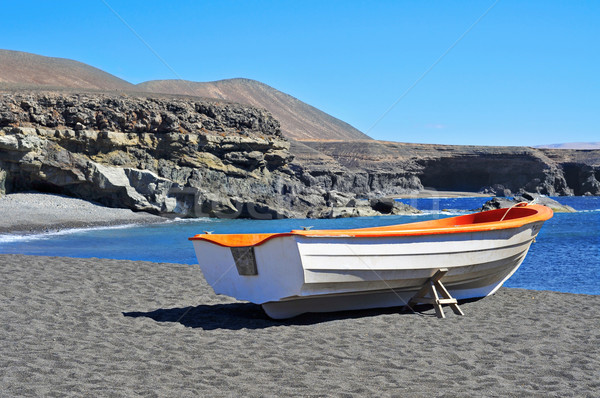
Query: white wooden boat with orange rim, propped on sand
190,204,553,319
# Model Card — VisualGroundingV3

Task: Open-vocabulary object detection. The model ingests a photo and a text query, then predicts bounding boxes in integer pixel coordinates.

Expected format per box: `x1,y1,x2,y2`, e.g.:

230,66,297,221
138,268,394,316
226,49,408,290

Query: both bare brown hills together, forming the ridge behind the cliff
0,50,371,140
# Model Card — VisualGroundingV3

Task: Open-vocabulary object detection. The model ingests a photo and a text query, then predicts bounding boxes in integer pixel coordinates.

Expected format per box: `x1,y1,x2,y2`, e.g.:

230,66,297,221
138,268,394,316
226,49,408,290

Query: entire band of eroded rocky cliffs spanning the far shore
0,91,600,219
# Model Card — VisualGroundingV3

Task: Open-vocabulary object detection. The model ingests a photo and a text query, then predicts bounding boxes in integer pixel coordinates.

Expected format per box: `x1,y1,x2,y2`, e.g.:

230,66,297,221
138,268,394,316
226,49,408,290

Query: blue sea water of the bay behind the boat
0,197,600,295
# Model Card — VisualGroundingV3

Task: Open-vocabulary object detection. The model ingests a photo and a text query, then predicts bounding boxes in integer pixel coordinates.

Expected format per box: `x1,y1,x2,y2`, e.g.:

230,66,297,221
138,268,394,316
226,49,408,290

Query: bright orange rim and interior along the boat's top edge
189,205,553,247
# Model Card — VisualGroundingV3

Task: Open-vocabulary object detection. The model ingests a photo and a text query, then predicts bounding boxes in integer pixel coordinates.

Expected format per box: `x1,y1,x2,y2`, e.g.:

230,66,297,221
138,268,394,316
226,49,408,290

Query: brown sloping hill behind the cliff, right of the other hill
137,79,370,140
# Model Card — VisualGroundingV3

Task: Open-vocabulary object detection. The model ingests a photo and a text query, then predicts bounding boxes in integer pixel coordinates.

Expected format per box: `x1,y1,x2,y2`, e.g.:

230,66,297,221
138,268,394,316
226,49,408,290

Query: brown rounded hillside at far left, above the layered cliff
0,50,135,91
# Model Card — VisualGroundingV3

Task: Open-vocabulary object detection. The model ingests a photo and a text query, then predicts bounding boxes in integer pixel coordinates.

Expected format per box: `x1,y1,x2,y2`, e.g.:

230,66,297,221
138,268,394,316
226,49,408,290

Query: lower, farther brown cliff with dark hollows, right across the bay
292,141,600,195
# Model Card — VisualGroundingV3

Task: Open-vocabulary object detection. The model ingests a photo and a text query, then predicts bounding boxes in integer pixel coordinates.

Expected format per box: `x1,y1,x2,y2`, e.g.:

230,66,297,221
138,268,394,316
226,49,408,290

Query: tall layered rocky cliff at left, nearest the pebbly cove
0,92,422,219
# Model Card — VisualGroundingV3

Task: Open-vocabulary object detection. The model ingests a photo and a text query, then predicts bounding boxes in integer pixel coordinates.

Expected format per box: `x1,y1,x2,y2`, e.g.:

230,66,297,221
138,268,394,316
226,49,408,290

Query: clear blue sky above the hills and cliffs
0,0,600,145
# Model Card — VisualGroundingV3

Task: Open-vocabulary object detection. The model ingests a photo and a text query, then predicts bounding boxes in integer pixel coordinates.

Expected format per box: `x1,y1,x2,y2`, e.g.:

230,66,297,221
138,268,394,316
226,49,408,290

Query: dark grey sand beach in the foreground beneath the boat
0,255,600,397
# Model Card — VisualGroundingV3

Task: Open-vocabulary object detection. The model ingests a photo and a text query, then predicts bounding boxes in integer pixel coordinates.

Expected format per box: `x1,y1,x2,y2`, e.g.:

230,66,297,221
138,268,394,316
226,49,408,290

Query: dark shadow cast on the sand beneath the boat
123,299,479,330
